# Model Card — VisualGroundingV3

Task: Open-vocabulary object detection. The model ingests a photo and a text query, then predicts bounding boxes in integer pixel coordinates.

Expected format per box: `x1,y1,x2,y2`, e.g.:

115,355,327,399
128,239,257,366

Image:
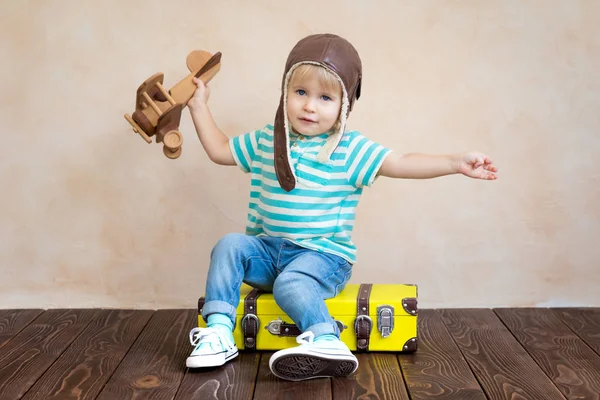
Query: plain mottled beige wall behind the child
0,0,600,308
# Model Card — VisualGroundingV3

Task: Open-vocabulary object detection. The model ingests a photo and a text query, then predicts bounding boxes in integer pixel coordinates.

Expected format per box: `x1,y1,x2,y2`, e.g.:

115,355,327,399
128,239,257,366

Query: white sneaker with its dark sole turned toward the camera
269,331,358,381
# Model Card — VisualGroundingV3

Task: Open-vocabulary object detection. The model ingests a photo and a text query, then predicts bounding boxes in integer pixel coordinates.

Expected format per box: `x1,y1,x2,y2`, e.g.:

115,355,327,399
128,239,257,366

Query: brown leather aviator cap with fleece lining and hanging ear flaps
274,33,362,192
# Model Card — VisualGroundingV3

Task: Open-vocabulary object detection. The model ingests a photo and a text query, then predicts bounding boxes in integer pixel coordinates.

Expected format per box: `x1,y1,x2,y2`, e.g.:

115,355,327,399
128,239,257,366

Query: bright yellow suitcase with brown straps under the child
198,284,418,352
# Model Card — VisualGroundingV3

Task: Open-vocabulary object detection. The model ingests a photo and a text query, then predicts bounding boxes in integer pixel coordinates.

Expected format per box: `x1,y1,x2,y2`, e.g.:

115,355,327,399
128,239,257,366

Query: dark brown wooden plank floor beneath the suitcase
0,308,600,400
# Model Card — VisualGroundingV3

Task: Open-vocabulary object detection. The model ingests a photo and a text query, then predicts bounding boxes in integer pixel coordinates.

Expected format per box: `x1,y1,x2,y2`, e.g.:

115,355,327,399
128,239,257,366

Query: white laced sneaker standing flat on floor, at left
185,328,238,368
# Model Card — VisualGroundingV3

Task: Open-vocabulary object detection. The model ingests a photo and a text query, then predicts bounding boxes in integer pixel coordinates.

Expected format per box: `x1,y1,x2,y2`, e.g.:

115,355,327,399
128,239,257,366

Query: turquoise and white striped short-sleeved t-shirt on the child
229,125,390,263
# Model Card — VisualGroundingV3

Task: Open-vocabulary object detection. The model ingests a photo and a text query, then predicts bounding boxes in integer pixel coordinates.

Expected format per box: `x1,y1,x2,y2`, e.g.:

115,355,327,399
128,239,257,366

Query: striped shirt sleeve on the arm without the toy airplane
346,134,391,188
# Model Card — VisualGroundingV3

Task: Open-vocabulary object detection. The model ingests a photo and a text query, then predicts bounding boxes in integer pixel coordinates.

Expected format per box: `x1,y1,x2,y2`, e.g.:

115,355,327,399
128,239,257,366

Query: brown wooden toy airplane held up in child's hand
125,50,221,158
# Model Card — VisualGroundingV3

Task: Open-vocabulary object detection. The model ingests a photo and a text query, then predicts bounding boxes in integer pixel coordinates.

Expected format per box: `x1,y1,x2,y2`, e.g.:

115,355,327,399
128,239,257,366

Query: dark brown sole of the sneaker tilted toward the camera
271,354,358,381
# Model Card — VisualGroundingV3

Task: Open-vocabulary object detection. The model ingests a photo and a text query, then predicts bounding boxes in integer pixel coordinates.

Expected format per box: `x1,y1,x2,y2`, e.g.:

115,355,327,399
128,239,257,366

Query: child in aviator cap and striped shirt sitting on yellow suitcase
186,34,497,380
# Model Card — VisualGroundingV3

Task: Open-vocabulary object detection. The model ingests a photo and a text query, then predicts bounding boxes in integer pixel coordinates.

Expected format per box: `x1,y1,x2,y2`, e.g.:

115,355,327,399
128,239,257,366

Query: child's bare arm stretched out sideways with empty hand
379,151,498,180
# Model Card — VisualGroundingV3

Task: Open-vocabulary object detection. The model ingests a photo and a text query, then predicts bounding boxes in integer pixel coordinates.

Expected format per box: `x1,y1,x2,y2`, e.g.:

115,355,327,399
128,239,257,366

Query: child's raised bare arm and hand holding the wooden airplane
187,78,236,165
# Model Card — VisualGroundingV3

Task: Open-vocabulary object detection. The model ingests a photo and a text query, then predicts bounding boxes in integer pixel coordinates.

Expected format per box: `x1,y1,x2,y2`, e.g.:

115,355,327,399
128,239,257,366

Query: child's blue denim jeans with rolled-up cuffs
202,233,352,337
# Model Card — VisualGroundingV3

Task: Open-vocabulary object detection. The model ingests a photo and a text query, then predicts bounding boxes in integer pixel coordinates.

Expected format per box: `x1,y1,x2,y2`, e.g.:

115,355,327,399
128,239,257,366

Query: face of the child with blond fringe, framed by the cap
286,69,342,136
